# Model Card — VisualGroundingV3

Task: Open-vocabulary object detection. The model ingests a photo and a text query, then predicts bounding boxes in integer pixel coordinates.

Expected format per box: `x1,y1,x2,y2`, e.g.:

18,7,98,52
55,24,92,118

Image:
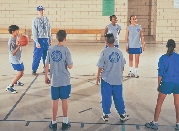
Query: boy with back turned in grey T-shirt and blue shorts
45,30,73,131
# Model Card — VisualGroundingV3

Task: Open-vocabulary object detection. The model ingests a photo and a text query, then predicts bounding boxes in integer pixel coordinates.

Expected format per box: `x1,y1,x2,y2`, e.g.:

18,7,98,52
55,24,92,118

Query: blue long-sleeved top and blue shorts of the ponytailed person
158,52,179,94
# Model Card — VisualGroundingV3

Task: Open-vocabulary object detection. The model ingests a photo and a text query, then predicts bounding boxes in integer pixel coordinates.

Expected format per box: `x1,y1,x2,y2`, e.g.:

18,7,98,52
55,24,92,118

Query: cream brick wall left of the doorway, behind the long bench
0,0,128,40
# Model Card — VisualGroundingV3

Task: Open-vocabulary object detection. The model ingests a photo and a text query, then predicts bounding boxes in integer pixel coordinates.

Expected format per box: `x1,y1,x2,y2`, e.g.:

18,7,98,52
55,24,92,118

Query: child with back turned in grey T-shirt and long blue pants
96,34,129,121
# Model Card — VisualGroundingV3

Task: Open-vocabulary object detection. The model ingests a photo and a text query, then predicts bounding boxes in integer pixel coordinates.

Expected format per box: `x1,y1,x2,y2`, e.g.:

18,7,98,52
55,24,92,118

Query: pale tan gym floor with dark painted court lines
0,39,179,131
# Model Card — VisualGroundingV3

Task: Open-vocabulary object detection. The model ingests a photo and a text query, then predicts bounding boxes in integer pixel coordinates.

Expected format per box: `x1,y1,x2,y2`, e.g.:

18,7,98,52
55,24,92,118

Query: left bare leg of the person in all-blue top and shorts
154,92,166,122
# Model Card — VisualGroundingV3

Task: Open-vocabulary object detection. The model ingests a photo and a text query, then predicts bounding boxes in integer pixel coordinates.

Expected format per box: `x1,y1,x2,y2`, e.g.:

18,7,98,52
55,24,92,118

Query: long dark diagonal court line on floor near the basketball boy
4,75,39,120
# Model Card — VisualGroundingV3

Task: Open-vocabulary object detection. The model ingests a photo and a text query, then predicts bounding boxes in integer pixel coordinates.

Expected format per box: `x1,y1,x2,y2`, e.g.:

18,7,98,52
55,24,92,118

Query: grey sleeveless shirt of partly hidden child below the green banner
107,24,121,48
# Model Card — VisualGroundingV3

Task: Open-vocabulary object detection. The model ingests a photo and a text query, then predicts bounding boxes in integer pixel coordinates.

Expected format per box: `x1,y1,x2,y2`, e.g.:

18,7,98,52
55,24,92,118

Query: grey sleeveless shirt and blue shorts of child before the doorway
128,24,142,54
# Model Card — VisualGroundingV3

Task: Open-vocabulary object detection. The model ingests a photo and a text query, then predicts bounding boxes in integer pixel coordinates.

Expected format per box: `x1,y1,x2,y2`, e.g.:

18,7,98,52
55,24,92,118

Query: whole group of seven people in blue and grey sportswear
6,6,179,131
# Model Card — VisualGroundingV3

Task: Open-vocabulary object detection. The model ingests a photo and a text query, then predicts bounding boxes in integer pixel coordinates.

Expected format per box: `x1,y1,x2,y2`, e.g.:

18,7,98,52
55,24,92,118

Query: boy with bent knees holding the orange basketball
6,25,24,93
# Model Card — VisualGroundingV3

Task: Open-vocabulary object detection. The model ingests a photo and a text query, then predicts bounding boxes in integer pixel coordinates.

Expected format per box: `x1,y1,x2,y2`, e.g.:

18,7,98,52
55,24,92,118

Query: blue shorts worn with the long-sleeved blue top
159,82,179,94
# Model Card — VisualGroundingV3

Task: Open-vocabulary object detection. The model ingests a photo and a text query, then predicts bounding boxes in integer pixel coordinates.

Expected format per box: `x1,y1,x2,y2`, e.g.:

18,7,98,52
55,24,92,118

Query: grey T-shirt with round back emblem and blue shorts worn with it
46,45,73,100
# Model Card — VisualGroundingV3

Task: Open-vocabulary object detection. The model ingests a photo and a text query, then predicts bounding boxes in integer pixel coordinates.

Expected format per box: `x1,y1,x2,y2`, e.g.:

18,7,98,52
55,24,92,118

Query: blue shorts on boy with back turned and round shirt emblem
51,85,71,100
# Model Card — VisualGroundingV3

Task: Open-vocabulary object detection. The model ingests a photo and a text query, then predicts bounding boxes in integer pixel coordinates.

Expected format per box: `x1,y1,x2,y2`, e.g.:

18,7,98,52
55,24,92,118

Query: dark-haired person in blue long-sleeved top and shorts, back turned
145,39,179,130
